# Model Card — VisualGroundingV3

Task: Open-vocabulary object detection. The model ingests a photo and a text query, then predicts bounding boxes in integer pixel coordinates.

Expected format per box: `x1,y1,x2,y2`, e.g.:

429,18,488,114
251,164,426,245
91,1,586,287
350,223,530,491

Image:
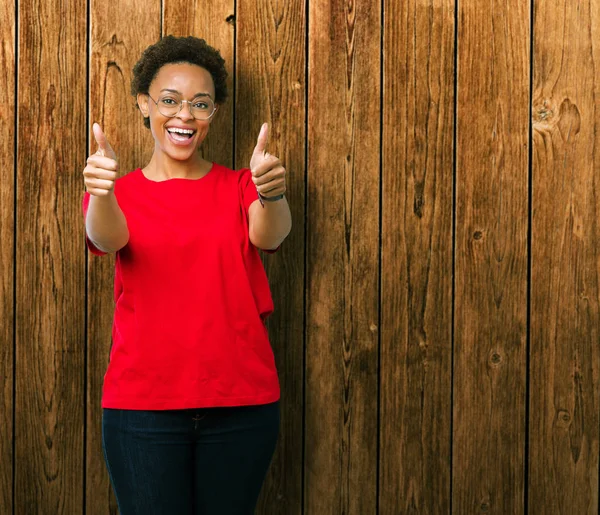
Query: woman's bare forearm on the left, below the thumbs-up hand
85,193,129,252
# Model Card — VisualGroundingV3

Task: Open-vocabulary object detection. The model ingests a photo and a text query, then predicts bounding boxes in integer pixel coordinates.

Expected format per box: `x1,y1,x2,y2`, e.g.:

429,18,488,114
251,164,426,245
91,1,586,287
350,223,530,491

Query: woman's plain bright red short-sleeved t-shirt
83,164,279,410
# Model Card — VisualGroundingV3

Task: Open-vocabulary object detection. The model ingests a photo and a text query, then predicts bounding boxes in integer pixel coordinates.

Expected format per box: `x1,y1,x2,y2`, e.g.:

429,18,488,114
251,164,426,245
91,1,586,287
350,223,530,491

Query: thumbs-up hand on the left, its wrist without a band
83,123,118,197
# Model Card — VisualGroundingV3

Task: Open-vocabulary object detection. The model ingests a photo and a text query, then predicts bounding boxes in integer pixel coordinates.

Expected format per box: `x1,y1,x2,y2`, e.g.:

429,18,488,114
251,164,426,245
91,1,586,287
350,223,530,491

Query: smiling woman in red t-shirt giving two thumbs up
83,36,291,515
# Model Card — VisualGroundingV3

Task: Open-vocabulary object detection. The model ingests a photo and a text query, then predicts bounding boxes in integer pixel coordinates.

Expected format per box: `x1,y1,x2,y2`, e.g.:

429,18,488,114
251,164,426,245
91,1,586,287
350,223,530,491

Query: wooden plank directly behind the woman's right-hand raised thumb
235,0,306,515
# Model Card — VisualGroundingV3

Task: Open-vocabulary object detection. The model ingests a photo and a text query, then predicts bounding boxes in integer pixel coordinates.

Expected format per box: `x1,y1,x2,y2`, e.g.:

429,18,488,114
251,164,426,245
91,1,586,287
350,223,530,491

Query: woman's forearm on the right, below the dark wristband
250,197,292,249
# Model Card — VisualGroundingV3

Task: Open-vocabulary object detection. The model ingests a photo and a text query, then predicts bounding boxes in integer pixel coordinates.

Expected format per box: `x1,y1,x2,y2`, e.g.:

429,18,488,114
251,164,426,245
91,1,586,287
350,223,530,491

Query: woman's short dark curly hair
131,36,228,129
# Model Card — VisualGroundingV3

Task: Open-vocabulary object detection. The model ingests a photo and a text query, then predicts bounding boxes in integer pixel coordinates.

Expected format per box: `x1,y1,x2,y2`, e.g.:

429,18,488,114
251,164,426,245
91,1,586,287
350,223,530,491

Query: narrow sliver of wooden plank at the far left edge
0,1,17,513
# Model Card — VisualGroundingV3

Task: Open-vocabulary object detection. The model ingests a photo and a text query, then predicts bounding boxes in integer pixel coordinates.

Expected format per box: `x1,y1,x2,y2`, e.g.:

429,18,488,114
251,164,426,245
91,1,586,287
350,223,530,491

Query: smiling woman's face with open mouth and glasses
137,63,215,161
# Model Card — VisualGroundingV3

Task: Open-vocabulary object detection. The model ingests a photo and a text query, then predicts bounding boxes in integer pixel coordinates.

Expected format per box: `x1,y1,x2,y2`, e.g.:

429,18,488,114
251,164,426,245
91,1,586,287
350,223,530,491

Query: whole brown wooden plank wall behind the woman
0,0,600,515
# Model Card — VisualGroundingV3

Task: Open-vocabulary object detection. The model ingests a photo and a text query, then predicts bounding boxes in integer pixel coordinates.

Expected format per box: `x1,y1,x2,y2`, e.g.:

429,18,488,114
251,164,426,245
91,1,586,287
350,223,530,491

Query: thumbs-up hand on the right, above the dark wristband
250,123,287,200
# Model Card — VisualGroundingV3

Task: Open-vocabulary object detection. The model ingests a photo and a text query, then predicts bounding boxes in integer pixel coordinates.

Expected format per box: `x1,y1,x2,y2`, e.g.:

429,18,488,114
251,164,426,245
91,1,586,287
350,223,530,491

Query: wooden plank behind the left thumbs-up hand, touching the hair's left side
87,0,161,514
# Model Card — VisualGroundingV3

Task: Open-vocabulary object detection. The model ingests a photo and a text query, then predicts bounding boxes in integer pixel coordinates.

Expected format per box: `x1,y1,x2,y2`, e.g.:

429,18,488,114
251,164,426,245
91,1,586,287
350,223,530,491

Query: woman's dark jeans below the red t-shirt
102,402,279,515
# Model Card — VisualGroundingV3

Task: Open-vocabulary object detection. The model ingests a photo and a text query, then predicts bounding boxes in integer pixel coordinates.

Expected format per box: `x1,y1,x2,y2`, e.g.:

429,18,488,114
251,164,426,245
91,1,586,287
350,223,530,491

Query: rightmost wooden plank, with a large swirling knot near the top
529,0,600,515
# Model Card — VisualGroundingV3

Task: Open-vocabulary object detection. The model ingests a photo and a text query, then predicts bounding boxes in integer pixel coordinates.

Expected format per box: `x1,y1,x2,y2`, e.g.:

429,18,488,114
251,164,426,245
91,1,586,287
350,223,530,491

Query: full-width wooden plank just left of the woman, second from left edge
14,0,86,514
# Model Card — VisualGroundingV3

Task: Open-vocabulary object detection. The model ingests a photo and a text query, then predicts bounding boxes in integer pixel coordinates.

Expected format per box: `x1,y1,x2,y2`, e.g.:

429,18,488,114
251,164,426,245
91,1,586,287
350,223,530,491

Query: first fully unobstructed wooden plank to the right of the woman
304,0,382,515
